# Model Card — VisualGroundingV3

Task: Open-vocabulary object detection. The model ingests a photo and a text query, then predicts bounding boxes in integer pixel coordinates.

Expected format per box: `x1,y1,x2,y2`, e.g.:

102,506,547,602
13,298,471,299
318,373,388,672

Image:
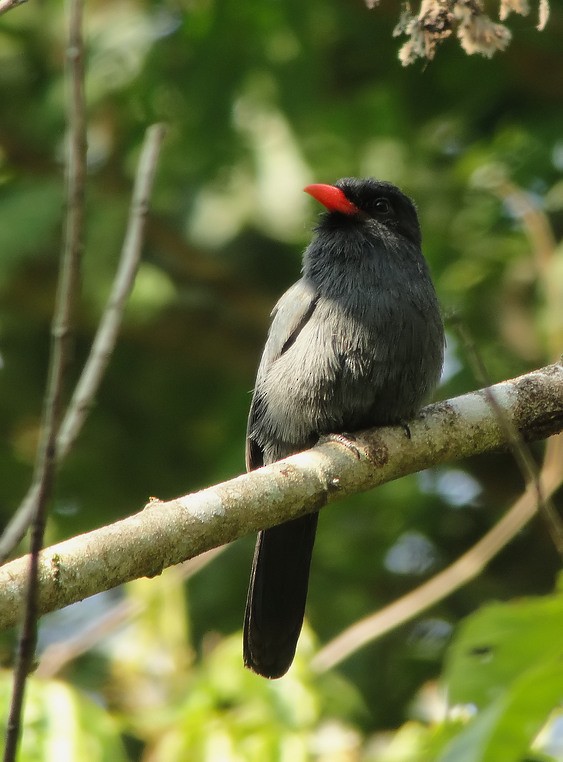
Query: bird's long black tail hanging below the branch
244,513,319,678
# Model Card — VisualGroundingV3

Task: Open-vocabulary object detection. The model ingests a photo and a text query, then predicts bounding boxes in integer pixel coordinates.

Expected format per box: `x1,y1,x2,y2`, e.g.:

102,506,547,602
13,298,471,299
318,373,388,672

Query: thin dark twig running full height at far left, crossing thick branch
4,0,86,762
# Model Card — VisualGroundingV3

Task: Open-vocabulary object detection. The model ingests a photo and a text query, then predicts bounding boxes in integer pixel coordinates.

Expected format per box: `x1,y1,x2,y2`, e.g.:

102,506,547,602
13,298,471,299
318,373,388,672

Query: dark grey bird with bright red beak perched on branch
243,177,445,679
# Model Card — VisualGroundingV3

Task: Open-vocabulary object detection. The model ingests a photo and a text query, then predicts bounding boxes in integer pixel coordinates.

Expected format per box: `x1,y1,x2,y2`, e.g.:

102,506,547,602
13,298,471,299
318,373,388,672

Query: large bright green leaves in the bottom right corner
439,591,563,762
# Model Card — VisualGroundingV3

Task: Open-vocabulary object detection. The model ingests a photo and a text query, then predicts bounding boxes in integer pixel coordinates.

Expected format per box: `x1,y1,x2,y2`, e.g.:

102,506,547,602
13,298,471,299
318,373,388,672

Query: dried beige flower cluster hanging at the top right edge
366,0,549,66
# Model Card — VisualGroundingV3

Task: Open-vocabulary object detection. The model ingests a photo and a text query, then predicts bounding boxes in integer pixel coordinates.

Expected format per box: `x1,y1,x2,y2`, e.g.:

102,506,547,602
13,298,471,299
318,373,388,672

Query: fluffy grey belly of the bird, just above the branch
260,300,441,450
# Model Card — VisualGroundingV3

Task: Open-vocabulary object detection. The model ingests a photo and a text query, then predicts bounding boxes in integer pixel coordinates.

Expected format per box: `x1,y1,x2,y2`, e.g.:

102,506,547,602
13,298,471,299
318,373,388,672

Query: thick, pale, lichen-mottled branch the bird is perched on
0,364,563,628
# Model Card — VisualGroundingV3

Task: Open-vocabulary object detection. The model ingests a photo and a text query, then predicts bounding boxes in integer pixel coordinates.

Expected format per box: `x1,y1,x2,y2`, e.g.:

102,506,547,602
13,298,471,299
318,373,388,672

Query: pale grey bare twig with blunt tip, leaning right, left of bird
0,124,165,563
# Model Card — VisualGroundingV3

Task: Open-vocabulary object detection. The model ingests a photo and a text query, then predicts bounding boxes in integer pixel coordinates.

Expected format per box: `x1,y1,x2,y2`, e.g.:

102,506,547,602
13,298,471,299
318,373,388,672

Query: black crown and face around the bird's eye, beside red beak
335,177,421,246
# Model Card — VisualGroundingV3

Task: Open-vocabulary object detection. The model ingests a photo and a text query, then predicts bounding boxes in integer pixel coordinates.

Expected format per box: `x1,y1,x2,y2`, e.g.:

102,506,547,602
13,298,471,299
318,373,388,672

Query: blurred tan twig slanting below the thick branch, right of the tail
312,436,563,672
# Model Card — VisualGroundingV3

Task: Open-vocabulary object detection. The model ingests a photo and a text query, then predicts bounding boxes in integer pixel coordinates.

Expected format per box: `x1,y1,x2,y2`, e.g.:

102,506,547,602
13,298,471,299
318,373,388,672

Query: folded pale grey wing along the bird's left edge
246,278,318,471
